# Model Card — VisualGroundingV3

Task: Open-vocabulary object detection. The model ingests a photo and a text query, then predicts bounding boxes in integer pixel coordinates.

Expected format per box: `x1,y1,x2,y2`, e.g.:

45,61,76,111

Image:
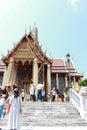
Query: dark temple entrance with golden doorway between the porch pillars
16,61,32,100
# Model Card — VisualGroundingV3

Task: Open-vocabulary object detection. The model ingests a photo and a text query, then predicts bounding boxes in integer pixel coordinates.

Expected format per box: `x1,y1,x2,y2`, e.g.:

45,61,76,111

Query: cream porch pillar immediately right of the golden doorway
32,58,38,93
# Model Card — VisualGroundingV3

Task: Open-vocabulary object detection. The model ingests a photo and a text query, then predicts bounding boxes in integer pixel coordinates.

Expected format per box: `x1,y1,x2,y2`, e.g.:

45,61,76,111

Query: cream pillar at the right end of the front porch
47,64,51,94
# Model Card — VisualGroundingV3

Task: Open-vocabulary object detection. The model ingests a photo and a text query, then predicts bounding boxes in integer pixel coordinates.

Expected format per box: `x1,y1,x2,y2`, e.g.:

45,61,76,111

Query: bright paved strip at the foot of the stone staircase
0,126,87,130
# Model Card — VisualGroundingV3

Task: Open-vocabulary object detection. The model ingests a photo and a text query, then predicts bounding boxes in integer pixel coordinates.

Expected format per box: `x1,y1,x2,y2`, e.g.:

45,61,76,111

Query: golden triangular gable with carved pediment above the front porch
2,33,51,63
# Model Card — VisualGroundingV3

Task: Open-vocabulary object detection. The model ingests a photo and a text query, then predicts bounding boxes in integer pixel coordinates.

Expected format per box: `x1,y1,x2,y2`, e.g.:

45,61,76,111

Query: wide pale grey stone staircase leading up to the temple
0,102,87,127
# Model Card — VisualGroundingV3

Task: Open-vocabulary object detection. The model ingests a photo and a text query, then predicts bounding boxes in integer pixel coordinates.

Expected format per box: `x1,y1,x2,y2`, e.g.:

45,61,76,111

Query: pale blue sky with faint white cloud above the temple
0,0,87,78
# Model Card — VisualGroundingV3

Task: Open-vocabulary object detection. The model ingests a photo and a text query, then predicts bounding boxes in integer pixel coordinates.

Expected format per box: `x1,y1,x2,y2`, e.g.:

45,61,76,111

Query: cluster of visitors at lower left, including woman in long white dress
0,86,22,130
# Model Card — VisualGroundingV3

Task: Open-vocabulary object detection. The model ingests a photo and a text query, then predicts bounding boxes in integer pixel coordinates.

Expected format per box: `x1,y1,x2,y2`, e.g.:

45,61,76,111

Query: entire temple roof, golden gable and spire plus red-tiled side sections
0,27,83,77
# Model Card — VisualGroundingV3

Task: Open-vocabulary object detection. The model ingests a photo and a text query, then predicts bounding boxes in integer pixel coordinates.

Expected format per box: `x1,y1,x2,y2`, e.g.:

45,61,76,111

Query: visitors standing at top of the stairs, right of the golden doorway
30,82,64,102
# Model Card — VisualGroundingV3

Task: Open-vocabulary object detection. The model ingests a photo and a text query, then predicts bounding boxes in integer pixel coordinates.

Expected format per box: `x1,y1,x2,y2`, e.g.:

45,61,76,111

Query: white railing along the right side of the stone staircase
69,89,87,120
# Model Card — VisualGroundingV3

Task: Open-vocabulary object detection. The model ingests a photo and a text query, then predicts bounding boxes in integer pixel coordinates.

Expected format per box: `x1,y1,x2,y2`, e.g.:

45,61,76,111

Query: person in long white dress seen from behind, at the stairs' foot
8,88,21,130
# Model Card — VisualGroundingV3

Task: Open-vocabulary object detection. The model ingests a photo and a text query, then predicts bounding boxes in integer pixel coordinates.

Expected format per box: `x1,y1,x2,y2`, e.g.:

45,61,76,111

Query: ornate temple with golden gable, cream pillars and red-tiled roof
0,26,83,98
